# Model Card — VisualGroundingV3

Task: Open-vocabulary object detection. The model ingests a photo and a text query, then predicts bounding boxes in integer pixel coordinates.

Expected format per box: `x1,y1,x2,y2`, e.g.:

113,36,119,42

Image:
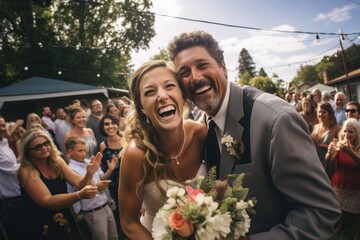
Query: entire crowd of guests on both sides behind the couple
0,81,360,239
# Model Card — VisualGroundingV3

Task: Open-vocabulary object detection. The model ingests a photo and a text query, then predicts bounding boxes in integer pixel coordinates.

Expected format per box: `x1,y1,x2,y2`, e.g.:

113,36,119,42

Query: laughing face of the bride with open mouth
139,67,184,129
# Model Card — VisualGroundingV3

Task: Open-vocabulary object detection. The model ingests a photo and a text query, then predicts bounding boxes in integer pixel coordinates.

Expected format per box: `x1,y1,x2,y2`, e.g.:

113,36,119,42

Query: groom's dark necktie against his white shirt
206,119,220,176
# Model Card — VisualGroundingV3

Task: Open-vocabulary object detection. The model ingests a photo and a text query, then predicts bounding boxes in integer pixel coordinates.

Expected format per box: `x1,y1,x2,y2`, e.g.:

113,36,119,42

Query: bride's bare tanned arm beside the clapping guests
119,141,152,240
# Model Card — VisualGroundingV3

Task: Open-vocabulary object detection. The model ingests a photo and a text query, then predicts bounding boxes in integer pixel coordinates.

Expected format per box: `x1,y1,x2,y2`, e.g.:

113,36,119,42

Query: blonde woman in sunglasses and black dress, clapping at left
18,130,102,240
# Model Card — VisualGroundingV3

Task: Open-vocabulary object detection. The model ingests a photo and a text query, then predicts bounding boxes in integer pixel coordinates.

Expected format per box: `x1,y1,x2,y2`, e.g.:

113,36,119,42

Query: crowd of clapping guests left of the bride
0,97,131,240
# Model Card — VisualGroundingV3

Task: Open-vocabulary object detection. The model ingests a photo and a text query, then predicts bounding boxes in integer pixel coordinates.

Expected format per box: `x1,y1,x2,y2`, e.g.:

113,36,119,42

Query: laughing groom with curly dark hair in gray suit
168,31,340,240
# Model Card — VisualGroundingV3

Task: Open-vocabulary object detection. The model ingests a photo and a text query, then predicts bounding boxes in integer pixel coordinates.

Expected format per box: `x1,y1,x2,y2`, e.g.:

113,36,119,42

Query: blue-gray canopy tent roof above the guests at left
0,77,108,105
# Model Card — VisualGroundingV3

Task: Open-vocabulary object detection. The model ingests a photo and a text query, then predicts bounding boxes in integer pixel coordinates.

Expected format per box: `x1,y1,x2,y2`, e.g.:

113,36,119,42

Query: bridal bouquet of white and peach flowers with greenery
152,167,256,240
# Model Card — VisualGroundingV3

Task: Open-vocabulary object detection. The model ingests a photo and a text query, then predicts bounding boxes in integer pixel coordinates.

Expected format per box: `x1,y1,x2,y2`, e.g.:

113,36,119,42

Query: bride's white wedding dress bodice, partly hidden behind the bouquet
141,163,207,232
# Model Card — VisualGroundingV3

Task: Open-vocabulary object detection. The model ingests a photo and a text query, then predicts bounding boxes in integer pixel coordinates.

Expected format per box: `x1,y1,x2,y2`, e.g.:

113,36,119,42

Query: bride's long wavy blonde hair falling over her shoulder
123,60,177,199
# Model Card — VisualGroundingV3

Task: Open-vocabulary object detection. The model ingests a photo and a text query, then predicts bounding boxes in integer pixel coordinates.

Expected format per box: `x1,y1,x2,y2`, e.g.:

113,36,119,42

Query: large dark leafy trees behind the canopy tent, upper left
0,0,155,87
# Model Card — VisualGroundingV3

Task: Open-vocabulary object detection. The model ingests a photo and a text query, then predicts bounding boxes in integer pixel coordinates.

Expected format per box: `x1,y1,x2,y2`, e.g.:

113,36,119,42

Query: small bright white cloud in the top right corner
313,4,357,22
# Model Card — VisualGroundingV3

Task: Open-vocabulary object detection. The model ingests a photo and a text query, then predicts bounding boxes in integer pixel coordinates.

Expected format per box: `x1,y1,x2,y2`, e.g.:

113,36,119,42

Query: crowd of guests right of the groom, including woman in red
284,89,360,240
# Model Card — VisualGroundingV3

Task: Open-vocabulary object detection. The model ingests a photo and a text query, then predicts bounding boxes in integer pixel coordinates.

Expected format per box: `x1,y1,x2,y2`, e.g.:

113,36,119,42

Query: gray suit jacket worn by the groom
205,83,341,240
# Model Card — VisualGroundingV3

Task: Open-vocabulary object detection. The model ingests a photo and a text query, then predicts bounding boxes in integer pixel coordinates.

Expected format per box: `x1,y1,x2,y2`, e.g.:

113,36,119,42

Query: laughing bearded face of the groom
174,46,227,116
